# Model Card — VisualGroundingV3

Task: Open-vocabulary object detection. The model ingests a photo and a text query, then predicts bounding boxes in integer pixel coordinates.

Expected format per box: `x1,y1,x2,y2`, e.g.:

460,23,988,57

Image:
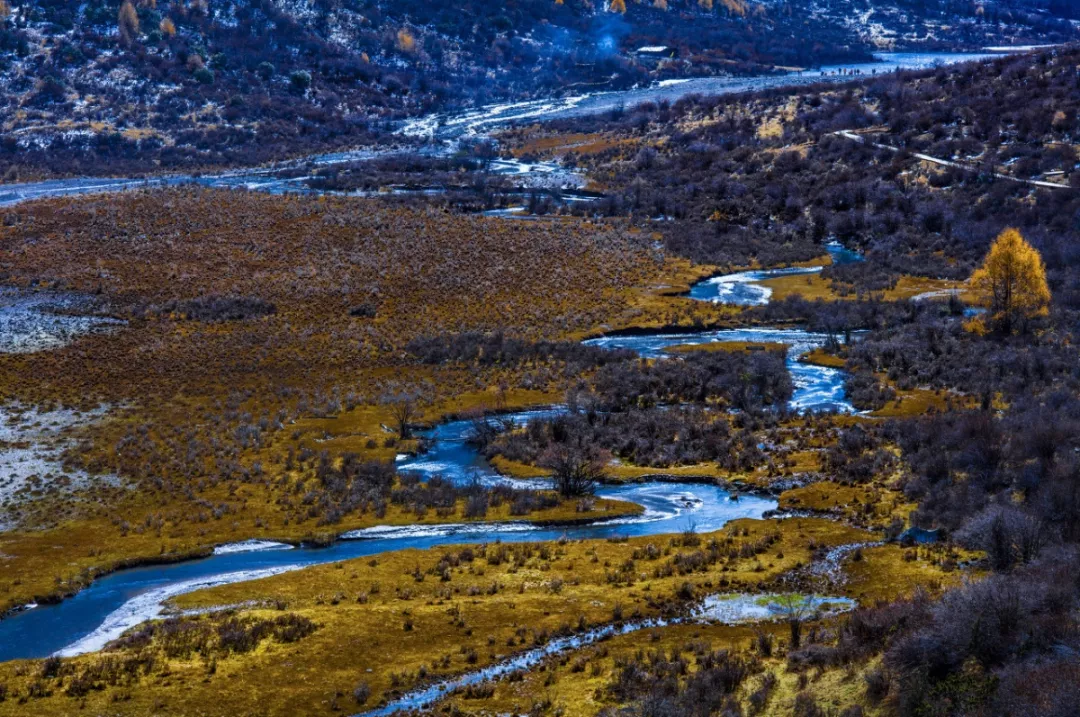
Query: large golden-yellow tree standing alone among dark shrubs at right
970,229,1050,334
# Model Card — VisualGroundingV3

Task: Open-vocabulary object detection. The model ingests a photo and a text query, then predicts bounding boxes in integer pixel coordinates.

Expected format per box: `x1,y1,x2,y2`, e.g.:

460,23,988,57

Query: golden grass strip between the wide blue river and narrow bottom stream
0,518,885,715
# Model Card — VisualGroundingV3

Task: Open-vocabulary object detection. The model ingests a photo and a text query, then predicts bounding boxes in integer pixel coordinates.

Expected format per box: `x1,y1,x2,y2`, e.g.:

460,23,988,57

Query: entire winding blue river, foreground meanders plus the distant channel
0,47,911,661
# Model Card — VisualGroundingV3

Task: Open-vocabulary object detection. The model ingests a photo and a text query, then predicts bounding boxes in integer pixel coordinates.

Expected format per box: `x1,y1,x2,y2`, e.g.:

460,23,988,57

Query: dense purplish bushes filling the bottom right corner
803,549,1080,717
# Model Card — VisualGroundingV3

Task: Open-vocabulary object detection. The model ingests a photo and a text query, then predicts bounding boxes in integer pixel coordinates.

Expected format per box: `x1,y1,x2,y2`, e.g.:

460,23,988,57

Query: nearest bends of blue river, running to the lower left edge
0,411,777,661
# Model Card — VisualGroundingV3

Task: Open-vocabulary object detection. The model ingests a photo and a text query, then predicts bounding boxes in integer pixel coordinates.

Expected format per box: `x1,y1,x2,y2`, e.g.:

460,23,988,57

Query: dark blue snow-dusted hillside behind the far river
0,0,1076,181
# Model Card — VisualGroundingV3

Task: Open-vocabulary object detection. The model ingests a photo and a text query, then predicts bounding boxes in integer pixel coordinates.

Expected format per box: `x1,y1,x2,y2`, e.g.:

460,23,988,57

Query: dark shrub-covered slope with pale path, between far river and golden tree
554,48,1080,308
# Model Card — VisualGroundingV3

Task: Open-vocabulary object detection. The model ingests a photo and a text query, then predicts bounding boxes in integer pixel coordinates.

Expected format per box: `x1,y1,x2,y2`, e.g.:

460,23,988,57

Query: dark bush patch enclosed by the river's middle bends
473,351,792,472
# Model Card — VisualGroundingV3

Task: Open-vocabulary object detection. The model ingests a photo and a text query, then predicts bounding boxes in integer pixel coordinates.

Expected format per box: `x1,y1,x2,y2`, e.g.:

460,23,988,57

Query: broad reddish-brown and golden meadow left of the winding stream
0,189,718,610
